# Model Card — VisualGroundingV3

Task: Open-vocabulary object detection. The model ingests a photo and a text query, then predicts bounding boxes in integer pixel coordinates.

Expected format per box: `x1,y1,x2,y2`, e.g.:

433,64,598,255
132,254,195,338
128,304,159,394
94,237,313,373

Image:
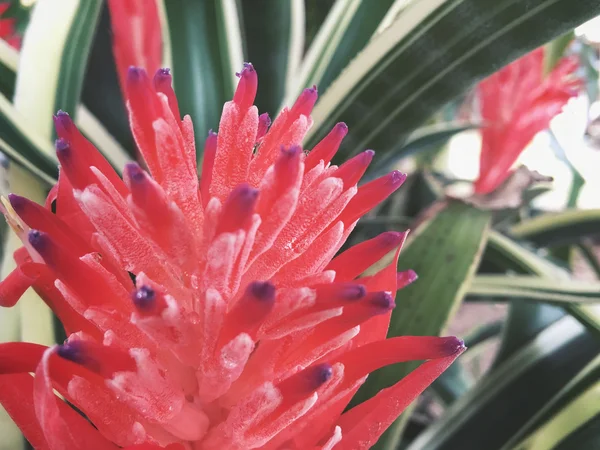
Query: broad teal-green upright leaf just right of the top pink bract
165,0,243,154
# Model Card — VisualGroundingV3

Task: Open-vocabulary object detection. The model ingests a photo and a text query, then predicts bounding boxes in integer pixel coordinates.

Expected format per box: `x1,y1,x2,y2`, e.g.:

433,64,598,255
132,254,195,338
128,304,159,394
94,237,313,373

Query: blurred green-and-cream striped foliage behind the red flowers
0,0,600,450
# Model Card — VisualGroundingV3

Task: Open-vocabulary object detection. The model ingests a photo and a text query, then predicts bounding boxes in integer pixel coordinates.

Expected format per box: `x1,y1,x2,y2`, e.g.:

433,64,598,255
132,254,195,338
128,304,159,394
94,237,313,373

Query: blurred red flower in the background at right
475,48,581,194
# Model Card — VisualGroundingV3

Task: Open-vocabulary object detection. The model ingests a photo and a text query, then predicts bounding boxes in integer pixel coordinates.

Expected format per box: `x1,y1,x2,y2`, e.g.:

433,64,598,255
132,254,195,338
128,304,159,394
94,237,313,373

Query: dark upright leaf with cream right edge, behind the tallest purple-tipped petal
241,0,304,114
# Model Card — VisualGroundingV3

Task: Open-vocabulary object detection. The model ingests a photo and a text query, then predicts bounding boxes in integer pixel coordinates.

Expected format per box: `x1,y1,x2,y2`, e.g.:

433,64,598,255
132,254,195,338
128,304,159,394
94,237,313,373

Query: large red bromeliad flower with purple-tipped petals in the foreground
0,64,464,450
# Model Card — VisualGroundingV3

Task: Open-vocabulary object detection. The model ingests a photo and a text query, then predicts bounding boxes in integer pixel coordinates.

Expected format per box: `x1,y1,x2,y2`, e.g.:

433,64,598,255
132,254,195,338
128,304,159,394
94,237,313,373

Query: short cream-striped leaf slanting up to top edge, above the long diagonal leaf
286,0,395,100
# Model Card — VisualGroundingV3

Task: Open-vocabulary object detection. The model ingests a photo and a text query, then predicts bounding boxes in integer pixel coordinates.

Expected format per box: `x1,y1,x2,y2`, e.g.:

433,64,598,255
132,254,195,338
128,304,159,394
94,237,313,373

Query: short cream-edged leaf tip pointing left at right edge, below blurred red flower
510,209,600,247
